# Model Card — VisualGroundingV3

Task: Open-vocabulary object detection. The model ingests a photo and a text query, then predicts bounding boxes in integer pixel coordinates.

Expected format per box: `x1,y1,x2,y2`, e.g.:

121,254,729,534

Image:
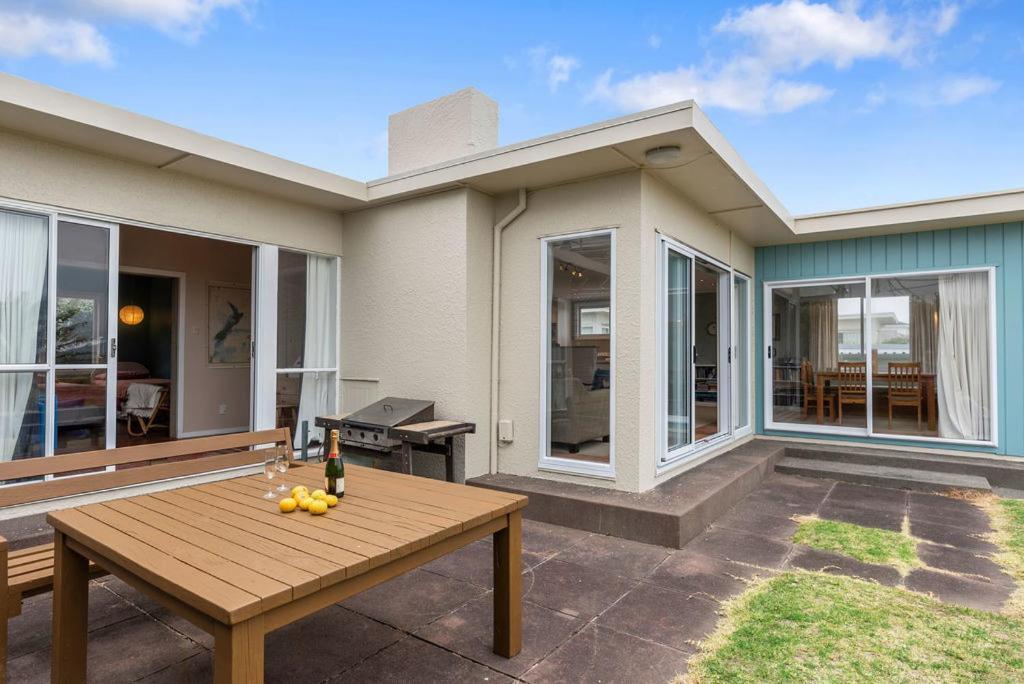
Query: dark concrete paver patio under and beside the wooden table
8,474,1014,682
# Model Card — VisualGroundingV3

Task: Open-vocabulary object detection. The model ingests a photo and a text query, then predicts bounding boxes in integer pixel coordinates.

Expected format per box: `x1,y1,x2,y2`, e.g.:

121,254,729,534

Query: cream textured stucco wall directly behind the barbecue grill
341,189,493,477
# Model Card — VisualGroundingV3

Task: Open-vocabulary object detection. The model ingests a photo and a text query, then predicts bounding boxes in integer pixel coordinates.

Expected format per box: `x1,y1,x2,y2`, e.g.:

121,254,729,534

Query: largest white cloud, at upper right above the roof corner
590,0,958,114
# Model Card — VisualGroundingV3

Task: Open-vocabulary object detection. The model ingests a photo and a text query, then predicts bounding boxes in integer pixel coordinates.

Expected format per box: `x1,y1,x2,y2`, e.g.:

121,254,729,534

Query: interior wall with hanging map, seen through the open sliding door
120,225,252,437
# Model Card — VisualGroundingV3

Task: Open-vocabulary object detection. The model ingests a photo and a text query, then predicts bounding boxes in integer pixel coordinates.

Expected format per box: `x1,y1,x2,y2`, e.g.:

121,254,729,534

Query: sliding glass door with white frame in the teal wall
765,268,995,444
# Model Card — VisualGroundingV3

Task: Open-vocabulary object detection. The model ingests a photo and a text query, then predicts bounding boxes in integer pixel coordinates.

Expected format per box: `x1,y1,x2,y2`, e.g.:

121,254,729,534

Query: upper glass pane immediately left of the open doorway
56,221,110,364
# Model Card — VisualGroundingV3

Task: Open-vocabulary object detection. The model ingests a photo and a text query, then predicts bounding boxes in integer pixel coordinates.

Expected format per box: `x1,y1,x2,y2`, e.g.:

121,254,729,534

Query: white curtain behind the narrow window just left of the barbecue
294,254,338,448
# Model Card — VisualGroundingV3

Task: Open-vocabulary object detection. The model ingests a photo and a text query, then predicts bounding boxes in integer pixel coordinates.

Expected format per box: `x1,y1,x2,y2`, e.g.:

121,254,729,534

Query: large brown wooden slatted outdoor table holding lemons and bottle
47,464,526,682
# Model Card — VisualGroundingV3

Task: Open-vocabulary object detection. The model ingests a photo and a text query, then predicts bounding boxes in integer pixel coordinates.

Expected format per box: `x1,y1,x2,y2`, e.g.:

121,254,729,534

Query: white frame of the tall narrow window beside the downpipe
538,227,618,479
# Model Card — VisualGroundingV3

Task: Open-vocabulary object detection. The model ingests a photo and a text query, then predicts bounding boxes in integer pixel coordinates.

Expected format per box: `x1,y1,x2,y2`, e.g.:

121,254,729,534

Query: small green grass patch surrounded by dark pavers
793,518,921,572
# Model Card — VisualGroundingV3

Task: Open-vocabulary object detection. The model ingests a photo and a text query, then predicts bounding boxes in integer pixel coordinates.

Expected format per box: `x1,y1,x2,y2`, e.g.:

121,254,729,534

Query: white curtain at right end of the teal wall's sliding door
936,272,991,439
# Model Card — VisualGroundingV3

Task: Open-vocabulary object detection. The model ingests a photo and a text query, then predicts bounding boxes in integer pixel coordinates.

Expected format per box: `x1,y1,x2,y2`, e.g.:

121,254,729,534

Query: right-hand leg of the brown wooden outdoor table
494,511,522,657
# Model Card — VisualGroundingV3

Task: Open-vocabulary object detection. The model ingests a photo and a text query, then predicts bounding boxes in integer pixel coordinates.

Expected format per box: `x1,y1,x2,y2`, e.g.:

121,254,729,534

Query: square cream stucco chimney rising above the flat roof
387,88,498,175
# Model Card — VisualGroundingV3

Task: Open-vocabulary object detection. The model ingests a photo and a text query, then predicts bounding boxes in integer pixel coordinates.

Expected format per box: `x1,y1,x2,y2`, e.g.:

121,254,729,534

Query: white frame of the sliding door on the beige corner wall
654,232,754,477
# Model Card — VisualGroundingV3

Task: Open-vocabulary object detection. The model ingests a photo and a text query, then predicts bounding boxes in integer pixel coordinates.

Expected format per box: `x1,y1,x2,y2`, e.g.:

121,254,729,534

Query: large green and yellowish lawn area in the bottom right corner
687,571,1024,684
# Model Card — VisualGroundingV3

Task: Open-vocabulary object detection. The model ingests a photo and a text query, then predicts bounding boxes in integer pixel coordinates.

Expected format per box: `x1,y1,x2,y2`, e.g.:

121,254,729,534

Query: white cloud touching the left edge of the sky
0,12,113,66
